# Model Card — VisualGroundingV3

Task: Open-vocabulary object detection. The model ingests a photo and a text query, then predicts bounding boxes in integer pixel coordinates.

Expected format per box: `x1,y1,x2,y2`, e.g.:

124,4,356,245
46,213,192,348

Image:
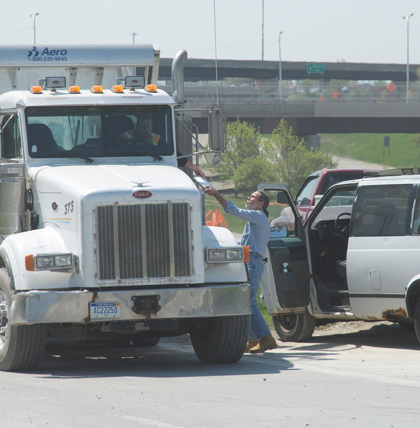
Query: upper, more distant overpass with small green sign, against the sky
159,58,420,82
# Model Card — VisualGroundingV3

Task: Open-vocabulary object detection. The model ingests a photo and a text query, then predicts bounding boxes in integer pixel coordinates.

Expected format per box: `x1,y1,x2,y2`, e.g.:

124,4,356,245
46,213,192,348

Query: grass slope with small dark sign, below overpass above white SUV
320,134,420,168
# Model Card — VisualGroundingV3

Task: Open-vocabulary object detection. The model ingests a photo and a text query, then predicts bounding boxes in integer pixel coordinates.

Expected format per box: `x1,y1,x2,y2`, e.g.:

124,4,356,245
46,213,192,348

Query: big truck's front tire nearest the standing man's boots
190,315,251,363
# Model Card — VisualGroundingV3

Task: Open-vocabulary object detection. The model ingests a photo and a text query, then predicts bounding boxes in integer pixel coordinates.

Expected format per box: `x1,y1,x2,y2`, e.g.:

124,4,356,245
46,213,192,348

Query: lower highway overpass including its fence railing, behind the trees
162,83,420,136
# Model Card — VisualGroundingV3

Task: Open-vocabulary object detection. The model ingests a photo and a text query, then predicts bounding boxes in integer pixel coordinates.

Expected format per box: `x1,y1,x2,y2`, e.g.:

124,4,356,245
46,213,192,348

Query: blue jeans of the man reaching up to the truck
246,254,271,342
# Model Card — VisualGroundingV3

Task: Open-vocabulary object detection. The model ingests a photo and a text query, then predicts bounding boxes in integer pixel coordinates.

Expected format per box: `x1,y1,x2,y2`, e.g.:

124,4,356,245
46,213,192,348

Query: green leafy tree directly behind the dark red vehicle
263,120,337,194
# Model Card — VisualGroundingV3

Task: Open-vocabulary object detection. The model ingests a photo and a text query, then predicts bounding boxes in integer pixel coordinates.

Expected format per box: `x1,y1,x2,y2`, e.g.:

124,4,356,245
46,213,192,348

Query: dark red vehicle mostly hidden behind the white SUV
270,169,378,230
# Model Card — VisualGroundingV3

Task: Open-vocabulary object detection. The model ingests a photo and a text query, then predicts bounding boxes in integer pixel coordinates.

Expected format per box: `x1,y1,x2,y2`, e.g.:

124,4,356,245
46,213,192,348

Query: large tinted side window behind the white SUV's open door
350,185,414,236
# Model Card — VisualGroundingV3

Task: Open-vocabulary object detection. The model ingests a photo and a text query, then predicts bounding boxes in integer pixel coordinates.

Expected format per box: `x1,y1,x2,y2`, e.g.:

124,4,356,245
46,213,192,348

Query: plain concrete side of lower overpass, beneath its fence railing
185,101,420,135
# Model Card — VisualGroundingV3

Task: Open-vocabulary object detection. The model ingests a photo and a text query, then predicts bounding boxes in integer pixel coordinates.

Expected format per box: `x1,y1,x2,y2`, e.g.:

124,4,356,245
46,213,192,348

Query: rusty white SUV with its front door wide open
260,168,420,341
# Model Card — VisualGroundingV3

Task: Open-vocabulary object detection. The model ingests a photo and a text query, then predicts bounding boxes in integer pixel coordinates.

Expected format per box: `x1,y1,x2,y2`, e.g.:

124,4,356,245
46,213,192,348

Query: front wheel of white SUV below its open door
272,309,316,342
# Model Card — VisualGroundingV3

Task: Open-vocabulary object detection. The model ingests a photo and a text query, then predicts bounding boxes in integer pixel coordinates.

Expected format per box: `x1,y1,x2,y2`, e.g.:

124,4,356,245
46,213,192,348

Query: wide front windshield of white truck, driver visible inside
26,106,174,158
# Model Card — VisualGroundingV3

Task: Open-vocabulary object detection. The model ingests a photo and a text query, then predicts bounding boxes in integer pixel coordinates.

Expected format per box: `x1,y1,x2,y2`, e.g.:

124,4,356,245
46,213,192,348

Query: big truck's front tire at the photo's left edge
0,268,47,371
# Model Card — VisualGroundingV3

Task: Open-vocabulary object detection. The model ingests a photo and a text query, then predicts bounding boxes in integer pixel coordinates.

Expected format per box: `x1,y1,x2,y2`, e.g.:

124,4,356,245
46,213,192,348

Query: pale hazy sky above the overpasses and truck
0,0,420,64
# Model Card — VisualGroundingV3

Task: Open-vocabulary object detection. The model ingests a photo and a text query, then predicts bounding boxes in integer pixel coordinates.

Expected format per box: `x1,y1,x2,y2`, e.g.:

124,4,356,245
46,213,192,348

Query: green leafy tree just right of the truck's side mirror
215,119,261,195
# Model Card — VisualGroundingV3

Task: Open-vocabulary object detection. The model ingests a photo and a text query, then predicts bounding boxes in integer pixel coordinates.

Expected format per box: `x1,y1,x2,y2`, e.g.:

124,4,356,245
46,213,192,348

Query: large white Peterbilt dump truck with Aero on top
0,45,250,370
